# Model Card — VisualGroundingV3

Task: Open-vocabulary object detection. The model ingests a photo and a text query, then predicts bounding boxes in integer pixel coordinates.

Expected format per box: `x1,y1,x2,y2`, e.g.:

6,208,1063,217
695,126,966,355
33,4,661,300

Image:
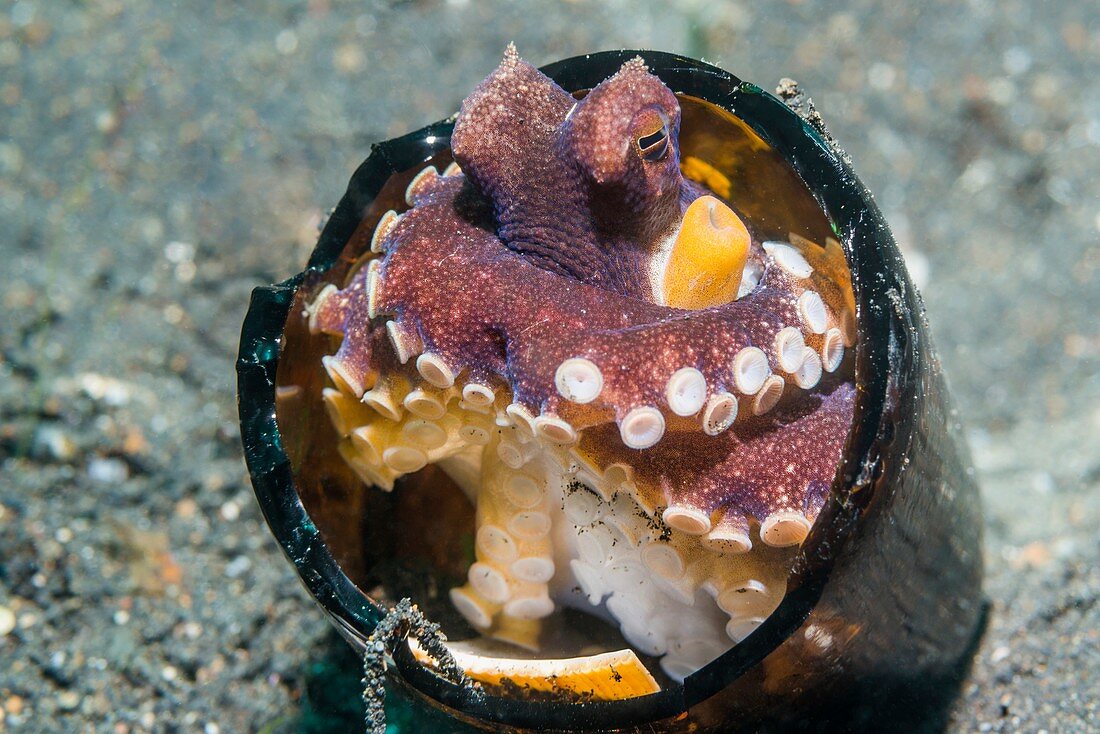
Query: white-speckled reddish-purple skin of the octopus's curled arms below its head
327,194,854,519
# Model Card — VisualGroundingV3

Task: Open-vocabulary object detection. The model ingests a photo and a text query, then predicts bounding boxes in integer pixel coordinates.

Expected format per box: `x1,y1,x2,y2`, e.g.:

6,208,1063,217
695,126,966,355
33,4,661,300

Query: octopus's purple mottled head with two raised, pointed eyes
451,48,703,298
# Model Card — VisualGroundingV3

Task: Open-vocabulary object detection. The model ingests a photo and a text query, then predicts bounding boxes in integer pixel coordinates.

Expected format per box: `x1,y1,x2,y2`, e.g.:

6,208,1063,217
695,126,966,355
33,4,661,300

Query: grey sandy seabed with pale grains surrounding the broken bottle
0,0,1100,734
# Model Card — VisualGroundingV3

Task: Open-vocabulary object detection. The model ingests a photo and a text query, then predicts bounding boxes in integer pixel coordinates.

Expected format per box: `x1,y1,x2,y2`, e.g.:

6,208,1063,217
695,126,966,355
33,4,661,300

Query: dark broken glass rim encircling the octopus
237,51,904,728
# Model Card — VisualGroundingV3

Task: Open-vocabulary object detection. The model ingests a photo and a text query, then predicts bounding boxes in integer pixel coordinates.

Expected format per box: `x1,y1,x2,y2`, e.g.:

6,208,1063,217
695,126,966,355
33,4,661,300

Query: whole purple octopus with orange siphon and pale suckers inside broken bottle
306,46,856,688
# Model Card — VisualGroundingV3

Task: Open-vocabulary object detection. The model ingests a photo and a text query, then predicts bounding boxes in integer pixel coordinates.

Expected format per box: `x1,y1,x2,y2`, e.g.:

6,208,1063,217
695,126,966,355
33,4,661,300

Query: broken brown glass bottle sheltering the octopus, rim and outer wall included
238,52,983,732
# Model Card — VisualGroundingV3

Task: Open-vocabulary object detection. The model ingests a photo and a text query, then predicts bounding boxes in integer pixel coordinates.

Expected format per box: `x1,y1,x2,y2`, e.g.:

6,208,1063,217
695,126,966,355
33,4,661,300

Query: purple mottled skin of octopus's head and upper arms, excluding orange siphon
315,51,855,534
